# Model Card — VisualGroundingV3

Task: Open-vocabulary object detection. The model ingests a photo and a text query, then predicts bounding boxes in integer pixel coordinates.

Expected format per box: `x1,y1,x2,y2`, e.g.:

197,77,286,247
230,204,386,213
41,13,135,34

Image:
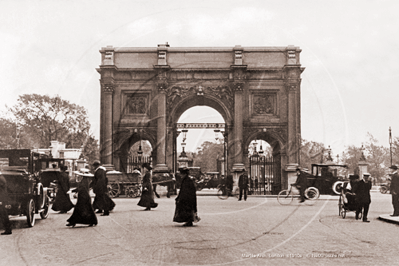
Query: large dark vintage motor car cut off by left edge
0,149,50,227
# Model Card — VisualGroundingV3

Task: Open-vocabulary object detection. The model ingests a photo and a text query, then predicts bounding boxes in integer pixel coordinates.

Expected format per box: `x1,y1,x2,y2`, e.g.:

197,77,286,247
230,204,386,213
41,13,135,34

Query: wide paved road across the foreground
0,192,399,265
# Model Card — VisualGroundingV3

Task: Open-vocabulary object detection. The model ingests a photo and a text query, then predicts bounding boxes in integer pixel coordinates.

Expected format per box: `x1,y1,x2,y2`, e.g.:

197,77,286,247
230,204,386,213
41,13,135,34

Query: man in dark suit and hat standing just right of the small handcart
352,173,372,223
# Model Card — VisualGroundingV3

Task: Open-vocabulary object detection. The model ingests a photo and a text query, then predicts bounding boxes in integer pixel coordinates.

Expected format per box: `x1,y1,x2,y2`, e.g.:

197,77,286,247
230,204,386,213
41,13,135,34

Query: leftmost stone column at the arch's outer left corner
100,84,114,164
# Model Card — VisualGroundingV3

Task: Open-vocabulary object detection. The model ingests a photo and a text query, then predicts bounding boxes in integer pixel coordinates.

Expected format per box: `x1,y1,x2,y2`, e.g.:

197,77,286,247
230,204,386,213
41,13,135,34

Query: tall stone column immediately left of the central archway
153,84,168,175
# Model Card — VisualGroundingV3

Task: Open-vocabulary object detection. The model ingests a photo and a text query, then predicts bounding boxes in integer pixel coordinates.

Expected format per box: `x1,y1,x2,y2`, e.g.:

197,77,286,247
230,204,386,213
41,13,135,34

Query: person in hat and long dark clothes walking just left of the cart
91,160,115,216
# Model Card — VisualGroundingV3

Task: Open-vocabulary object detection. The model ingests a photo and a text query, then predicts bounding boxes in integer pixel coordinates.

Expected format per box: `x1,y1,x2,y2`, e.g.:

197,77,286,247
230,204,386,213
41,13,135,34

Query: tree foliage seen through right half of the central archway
194,141,223,173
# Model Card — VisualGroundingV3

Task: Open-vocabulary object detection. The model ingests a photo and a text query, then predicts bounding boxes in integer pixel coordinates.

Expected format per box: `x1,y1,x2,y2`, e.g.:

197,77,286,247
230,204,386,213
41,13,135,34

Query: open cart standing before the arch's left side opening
107,170,141,198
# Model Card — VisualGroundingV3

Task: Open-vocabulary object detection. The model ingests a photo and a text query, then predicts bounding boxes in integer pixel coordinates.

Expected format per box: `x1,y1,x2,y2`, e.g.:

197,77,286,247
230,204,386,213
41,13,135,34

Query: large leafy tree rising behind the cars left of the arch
8,94,90,148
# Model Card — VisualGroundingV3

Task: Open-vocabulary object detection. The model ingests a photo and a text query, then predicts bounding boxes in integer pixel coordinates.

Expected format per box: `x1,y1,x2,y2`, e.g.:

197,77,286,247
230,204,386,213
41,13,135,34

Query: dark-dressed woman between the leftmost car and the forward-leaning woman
51,165,73,213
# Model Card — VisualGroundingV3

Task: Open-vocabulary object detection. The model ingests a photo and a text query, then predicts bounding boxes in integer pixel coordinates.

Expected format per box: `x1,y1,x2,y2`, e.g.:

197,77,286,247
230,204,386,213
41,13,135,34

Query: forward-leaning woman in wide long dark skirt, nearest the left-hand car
67,175,97,226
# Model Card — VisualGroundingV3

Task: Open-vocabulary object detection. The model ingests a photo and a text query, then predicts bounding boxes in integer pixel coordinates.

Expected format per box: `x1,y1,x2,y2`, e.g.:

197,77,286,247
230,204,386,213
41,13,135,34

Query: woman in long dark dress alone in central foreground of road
173,168,197,226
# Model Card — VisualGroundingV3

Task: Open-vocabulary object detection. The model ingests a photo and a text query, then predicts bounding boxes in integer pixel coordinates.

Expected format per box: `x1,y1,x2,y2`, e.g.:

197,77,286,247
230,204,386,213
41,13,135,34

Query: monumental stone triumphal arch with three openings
97,43,304,187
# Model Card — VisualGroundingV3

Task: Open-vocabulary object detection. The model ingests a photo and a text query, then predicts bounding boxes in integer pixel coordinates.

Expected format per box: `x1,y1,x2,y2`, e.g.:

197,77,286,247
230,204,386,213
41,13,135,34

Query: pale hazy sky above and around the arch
0,0,399,156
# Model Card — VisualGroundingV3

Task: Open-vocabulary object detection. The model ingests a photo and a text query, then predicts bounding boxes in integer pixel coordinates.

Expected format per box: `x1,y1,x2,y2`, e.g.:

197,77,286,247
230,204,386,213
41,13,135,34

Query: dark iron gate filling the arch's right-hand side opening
249,154,281,195
